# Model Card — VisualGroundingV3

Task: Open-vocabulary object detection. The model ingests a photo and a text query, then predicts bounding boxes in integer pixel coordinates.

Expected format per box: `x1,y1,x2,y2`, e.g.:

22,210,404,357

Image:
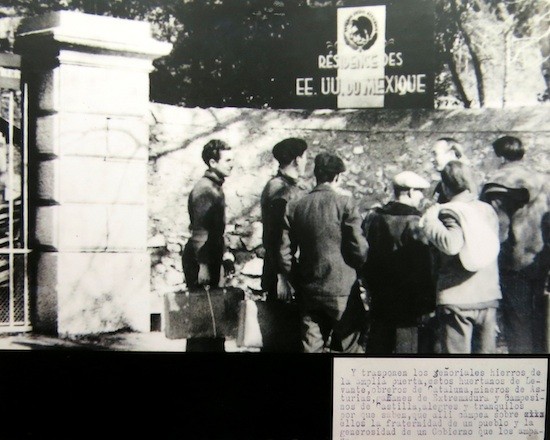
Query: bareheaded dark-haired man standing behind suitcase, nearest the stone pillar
182,139,233,351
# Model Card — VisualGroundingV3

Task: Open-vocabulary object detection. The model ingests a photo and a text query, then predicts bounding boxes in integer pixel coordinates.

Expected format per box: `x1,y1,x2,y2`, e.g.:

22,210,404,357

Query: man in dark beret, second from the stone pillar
260,138,307,351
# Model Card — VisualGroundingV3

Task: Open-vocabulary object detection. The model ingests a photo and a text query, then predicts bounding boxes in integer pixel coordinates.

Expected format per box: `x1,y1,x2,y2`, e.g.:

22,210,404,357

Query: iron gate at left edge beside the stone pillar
0,54,31,332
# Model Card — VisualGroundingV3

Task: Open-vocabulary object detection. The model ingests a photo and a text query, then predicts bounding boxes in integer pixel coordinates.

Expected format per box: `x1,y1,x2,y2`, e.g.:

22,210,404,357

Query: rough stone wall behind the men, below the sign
149,104,550,312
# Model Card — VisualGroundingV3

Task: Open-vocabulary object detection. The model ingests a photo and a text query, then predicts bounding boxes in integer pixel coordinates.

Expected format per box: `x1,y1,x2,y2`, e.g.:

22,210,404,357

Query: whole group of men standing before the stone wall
183,136,550,354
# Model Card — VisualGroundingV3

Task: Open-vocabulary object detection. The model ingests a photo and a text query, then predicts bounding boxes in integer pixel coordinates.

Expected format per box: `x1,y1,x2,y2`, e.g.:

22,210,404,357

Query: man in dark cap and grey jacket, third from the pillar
279,153,367,353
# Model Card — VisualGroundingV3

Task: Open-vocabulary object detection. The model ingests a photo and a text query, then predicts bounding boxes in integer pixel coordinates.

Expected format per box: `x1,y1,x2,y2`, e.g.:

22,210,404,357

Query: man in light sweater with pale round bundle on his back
421,161,502,353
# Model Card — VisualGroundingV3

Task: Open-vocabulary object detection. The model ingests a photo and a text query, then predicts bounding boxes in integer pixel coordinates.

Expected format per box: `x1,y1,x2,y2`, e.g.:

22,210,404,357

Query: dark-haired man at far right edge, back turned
481,136,550,353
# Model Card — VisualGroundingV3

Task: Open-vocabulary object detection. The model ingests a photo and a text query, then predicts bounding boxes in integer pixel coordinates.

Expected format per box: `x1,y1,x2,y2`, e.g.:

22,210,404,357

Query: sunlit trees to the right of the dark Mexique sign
436,0,550,107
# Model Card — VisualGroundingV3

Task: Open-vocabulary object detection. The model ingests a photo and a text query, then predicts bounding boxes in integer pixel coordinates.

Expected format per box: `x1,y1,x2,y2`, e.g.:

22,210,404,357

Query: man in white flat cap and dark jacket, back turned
363,171,435,354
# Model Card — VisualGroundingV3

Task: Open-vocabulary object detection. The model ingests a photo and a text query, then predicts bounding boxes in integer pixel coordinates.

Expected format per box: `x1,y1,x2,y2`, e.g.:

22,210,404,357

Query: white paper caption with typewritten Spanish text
333,358,548,440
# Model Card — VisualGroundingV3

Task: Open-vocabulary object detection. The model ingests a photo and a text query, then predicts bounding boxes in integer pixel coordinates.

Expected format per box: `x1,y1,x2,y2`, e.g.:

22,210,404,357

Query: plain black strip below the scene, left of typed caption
0,350,332,440
